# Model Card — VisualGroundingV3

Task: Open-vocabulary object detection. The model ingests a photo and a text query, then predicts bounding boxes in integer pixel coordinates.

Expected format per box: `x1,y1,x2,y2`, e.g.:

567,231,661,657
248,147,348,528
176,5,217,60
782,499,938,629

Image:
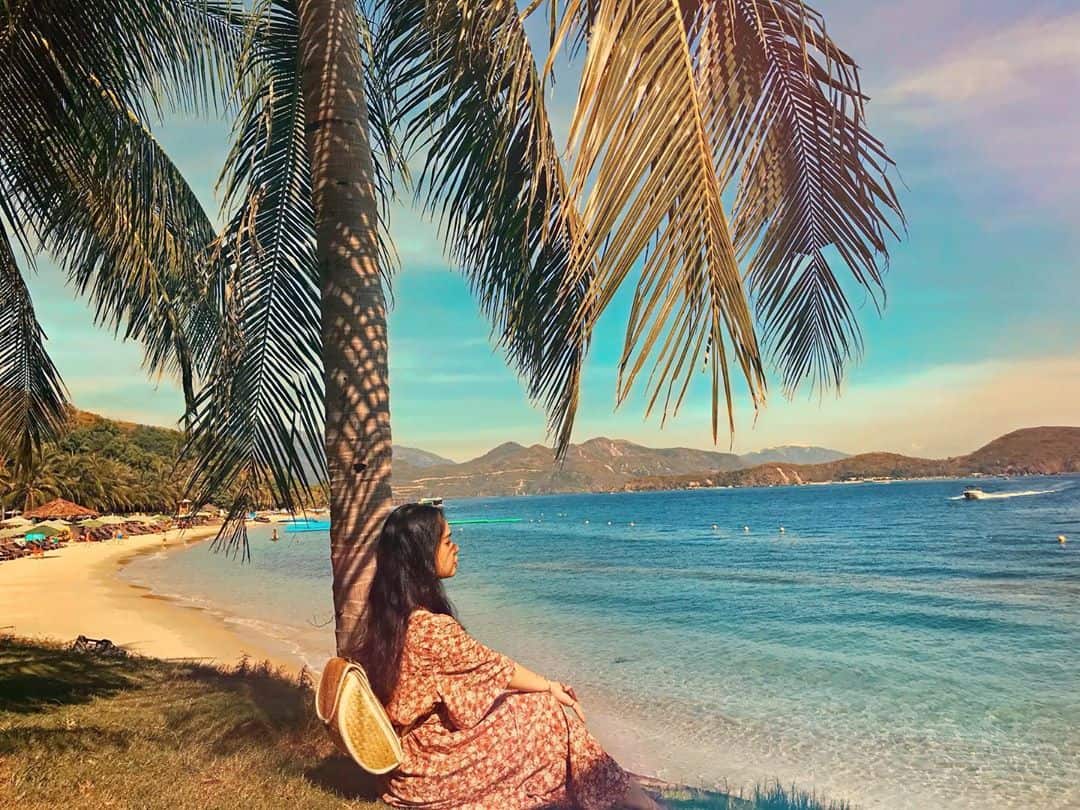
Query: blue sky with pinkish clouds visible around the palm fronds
23,0,1080,459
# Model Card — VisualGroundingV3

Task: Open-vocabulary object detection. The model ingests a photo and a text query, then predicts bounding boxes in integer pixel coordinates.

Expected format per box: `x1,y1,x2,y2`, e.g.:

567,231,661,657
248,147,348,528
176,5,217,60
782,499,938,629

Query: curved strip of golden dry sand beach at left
0,526,298,672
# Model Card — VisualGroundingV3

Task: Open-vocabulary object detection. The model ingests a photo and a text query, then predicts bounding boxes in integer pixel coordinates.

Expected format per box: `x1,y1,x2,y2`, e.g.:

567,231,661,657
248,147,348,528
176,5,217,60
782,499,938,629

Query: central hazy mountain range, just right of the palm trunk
393,437,742,498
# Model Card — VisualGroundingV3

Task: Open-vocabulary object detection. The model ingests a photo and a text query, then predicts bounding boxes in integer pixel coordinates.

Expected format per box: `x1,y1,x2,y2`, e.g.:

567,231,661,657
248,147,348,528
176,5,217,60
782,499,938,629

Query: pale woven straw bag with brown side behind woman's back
315,658,405,773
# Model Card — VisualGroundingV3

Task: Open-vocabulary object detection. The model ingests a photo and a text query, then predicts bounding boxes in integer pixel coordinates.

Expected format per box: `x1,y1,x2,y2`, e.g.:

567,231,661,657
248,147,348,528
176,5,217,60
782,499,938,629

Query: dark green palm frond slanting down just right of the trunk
377,0,592,454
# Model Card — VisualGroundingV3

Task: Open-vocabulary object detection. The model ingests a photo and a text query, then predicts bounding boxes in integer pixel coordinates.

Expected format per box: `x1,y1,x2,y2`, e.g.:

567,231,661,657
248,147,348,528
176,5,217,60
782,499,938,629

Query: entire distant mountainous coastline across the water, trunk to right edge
393,427,1080,498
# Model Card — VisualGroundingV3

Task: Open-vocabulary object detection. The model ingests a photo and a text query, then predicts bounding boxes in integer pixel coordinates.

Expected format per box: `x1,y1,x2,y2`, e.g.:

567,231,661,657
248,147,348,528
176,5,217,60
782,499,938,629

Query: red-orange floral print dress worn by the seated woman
382,610,629,810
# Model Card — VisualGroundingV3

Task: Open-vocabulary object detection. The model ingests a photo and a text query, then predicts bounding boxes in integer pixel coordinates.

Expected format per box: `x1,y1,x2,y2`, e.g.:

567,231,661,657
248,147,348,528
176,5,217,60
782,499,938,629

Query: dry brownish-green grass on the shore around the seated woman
0,637,851,810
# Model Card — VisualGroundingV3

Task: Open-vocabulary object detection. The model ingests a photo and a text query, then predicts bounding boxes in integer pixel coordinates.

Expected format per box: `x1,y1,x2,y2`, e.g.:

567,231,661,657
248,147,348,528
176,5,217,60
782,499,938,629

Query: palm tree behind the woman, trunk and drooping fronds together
185,0,903,650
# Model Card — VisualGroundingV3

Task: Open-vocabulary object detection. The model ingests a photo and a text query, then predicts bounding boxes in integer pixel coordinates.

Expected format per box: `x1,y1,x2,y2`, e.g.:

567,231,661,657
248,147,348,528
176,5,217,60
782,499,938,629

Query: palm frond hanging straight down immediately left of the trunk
187,0,325,556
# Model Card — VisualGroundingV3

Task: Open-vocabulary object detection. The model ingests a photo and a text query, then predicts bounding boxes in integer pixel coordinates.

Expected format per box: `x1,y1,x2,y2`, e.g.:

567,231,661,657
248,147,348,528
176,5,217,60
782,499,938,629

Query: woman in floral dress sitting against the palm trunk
354,503,660,810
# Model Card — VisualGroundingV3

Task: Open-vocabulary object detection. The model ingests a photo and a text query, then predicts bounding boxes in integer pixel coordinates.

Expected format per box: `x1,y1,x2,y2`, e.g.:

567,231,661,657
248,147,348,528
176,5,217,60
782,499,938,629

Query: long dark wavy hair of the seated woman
353,503,454,705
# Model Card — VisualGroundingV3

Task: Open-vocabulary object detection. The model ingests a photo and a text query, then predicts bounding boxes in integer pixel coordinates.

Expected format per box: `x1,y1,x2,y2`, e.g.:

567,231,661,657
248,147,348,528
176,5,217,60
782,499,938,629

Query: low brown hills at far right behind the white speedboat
626,427,1080,490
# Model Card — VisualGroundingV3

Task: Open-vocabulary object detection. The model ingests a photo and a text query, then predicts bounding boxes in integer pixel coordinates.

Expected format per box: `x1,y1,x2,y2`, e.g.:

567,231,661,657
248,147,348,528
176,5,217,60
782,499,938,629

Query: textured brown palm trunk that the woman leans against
297,0,392,652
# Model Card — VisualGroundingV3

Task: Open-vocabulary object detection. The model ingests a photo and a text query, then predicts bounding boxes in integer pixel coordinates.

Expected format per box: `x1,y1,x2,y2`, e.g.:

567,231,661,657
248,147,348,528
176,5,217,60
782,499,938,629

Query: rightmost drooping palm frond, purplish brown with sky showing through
687,0,903,393
